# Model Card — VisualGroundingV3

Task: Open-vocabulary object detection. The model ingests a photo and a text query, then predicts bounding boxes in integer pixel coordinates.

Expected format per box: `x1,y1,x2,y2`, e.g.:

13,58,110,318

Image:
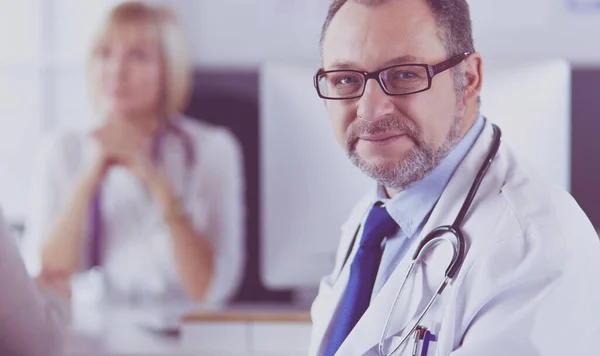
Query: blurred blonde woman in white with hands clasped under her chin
24,2,244,303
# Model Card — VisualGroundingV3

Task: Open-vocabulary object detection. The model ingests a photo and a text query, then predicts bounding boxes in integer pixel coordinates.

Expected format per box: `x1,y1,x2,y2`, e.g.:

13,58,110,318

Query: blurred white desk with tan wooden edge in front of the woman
66,306,311,356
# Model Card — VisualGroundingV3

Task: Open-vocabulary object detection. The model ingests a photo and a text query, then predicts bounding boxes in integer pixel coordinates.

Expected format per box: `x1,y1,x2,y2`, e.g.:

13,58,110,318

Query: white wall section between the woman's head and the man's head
168,0,328,67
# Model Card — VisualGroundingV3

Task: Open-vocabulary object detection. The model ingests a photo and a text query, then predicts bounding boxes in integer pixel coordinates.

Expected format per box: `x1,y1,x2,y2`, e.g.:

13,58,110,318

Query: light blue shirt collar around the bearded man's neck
374,114,486,238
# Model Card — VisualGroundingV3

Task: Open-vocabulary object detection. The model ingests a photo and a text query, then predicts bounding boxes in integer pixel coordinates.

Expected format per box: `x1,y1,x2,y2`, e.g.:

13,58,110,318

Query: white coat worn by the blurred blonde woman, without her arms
23,116,245,304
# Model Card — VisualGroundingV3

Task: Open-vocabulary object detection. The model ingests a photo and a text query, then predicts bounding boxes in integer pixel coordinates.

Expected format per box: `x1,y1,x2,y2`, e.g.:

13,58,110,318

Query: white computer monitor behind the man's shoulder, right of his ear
481,59,571,191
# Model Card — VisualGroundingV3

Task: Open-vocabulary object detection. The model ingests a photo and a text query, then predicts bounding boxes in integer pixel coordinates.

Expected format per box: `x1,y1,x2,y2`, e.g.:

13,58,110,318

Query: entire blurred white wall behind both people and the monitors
0,0,600,219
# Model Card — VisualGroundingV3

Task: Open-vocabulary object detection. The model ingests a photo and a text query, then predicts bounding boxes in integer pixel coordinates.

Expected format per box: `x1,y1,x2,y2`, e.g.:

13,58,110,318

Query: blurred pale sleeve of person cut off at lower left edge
0,212,70,356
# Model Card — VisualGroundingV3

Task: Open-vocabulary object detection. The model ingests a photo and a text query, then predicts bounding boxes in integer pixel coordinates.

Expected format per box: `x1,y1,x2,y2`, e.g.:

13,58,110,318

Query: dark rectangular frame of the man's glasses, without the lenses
313,52,472,100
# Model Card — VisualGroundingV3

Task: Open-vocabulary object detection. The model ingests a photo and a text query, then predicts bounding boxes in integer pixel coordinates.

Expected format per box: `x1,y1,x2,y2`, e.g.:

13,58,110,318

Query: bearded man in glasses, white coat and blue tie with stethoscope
310,0,600,356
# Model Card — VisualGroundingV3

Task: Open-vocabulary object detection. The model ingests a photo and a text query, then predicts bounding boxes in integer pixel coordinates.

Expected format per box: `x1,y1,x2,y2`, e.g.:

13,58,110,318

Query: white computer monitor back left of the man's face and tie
259,64,373,289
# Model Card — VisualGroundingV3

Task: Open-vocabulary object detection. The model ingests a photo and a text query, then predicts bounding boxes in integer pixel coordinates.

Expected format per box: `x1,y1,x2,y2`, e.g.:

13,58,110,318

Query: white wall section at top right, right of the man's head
470,0,600,64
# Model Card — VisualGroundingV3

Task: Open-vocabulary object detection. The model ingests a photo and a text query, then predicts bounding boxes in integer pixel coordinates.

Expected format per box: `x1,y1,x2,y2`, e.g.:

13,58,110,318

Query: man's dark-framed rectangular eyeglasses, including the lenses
314,52,471,100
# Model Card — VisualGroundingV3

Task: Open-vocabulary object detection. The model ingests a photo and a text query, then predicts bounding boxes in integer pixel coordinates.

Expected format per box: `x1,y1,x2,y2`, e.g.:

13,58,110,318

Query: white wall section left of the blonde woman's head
0,0,119,221
